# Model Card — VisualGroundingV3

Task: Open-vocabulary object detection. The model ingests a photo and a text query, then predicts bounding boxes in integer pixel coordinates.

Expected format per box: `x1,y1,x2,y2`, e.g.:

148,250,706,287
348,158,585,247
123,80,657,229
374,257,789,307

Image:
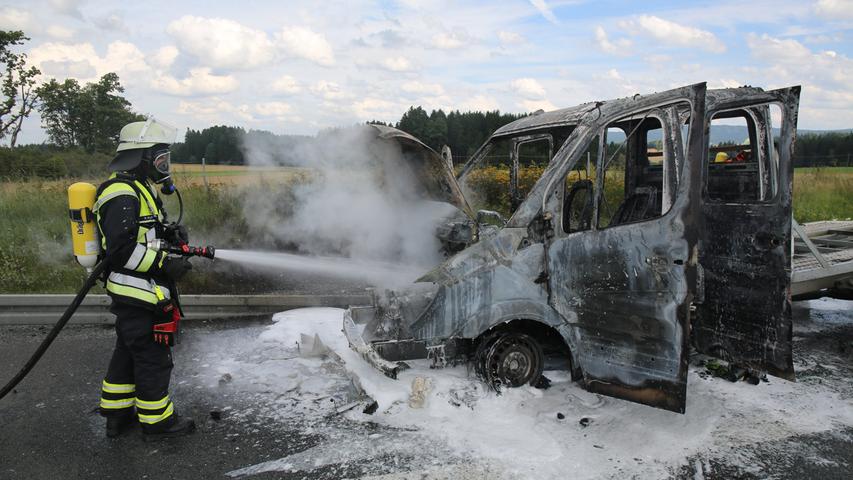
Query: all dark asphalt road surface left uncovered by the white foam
0,300,853,479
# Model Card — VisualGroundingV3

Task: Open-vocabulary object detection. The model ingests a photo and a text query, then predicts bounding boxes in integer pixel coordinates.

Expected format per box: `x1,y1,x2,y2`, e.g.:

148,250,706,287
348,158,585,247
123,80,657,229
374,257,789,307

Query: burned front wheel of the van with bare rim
477,332,545,389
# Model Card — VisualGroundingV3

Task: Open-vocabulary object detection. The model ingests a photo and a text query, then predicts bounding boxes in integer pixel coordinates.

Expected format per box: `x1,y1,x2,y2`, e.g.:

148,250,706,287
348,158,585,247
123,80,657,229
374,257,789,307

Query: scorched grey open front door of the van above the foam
543,83,706,413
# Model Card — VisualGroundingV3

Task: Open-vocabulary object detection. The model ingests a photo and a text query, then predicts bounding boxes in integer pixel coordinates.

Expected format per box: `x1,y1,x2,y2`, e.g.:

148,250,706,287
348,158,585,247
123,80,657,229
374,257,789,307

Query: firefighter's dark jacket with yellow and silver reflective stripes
93,174,174,309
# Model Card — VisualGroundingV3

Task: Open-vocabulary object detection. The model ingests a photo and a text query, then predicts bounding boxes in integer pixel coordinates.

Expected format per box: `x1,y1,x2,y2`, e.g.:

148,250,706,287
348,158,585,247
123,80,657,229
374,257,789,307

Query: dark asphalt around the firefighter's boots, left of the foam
0,323,326,479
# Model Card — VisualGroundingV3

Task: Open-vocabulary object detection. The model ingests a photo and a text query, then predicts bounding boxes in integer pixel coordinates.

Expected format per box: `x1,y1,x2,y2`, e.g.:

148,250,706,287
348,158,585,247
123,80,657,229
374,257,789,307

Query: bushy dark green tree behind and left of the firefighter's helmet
36,73,144,152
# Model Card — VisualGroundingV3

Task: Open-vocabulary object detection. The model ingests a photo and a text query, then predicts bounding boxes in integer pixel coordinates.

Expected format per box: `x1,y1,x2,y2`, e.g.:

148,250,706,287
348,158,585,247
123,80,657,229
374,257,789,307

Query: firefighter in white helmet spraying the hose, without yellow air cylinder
93,118,195,439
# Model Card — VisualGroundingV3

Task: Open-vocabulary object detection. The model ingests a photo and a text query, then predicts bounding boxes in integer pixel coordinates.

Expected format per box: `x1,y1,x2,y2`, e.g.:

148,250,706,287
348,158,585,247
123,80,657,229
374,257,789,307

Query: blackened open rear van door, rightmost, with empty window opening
691,86,800,380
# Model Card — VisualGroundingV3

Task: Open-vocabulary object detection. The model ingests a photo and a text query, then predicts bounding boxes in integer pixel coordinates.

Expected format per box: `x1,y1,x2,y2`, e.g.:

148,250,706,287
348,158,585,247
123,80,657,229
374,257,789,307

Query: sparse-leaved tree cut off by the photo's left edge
0,30,41,147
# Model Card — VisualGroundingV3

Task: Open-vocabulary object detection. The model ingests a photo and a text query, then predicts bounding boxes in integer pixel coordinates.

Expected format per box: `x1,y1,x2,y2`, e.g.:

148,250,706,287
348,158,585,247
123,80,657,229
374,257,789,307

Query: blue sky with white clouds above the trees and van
0,0,853,143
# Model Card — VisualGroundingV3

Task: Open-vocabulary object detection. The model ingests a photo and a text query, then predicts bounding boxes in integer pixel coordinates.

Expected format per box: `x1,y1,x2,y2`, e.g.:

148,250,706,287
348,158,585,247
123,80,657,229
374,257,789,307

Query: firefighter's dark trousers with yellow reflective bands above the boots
100,302,174,425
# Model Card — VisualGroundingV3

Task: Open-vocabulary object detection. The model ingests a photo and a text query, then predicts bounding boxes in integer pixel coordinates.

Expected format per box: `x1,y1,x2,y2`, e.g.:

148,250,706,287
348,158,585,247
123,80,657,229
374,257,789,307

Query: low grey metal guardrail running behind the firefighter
0,294,371,325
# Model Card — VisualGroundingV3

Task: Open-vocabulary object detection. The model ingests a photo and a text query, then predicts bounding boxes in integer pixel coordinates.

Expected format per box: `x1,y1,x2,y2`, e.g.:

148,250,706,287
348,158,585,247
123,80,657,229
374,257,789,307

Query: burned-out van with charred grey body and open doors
344,83,800,412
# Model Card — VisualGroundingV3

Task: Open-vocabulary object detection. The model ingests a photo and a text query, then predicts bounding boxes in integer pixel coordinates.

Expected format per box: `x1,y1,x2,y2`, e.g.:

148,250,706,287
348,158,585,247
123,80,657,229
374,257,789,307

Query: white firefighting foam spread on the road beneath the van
183,301,853,478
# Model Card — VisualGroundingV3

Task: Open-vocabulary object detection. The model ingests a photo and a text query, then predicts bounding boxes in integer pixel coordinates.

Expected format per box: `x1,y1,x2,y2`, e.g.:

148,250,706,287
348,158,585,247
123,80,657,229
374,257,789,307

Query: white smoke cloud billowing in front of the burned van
236,127,453,267
